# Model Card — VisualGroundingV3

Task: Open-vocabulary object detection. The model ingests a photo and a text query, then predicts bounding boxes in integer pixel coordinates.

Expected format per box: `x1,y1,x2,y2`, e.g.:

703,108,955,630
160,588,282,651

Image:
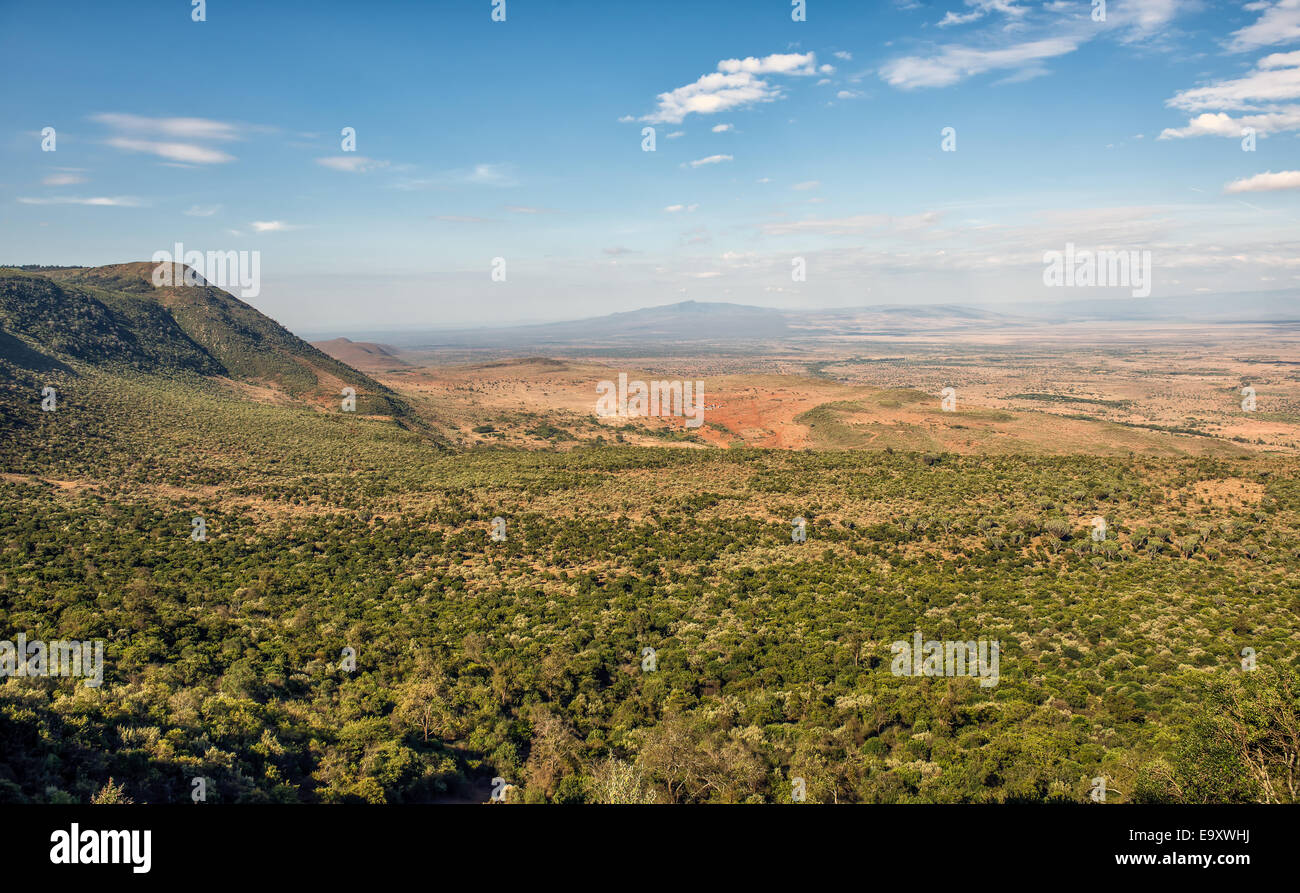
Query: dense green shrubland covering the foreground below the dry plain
0,369,1300,802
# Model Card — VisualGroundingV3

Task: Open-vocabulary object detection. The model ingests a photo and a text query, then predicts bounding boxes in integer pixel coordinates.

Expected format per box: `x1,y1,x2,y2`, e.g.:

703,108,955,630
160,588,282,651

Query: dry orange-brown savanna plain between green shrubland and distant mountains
361,322,1300,456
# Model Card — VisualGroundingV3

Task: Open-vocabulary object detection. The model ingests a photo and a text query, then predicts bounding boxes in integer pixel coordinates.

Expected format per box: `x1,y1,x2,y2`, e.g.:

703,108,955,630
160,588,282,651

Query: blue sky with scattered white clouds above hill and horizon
0,0,1300,333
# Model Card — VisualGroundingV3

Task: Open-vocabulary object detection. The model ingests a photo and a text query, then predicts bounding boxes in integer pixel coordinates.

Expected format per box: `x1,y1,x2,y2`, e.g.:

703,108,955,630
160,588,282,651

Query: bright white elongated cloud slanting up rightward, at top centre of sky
642,53,828,123
